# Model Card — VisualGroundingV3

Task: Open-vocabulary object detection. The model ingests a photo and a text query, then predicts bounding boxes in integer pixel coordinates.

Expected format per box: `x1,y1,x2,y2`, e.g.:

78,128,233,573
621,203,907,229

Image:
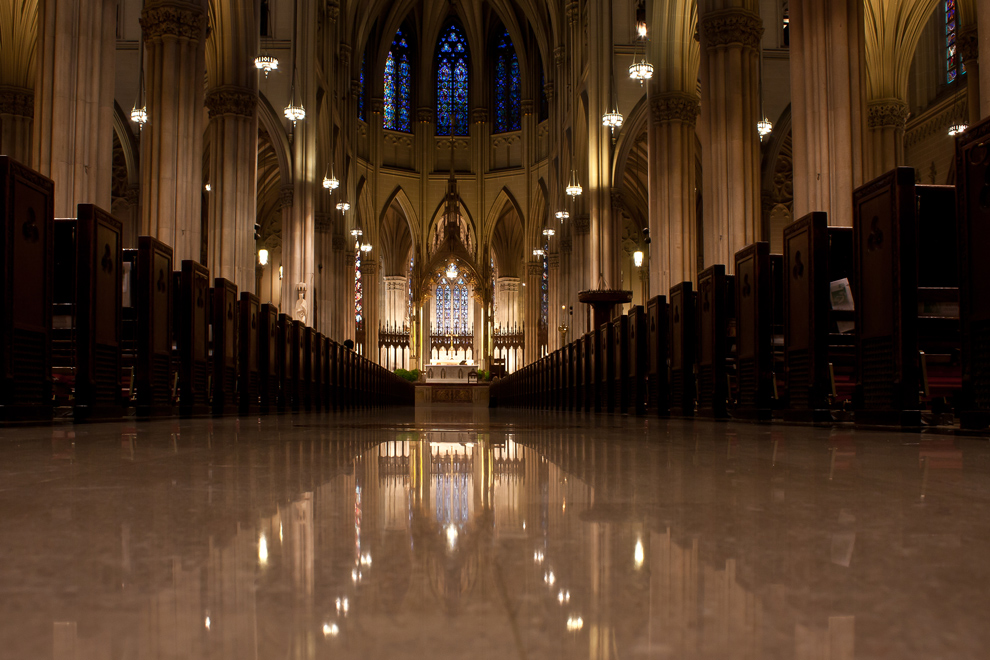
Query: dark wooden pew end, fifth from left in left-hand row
210,277,240,416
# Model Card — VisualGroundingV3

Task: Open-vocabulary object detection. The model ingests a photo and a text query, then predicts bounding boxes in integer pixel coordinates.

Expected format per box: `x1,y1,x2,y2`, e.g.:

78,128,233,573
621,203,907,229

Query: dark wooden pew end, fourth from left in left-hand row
175,259,211,417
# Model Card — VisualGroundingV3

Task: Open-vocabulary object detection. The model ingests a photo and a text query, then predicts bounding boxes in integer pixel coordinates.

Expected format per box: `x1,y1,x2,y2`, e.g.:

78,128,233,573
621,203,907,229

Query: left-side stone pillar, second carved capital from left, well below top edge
206,86,258,291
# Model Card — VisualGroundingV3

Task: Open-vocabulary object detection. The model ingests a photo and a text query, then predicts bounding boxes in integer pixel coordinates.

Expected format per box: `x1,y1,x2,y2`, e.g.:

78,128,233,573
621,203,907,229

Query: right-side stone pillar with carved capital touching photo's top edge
698,0,763,271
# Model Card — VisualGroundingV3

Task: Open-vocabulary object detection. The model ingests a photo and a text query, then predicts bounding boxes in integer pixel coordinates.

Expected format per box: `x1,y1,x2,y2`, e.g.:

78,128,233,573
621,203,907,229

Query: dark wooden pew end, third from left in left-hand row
131,236,178,417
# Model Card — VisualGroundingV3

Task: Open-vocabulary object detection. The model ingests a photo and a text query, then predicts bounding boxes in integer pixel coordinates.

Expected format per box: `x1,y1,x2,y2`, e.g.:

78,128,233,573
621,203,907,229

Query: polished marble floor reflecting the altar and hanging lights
0,408,990,660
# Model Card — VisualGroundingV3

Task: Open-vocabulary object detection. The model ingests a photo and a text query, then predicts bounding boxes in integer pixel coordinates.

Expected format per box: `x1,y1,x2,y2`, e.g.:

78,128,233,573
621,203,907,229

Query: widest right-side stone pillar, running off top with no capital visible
790,0,864,227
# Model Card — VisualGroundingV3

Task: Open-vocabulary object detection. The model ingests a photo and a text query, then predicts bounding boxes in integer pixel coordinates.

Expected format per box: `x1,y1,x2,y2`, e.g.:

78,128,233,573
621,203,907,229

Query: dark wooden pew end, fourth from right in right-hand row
733,241,774,421
